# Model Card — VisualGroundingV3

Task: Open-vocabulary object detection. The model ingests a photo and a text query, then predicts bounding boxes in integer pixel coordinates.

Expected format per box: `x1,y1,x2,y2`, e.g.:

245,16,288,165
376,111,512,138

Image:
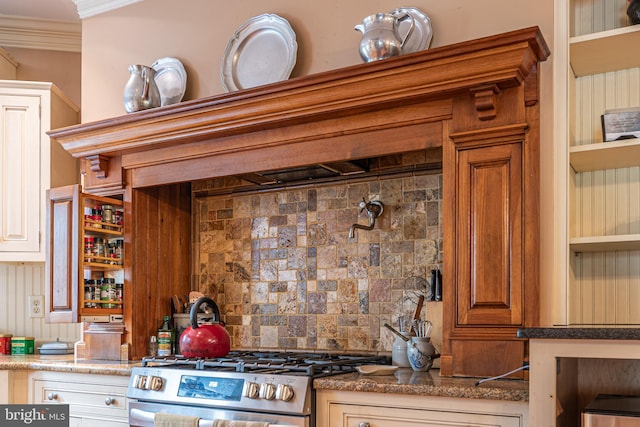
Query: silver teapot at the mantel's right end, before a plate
355,13,415,62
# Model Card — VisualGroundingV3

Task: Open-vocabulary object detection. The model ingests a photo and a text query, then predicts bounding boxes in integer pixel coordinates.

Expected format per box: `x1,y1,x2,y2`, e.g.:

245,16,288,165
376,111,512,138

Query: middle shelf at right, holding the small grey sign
569,139,640,172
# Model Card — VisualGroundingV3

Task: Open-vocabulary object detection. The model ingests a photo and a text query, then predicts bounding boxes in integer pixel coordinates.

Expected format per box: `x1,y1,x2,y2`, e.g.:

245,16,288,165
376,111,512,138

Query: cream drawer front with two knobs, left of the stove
34,380,128,418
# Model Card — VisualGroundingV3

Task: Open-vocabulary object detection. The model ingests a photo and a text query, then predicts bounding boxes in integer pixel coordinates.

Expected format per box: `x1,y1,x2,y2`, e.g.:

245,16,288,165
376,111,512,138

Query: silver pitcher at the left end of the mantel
122,65,160,113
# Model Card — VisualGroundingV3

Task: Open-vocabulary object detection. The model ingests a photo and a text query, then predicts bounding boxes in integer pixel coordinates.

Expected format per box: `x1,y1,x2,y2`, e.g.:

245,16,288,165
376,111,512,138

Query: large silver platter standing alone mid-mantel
220,13,298,92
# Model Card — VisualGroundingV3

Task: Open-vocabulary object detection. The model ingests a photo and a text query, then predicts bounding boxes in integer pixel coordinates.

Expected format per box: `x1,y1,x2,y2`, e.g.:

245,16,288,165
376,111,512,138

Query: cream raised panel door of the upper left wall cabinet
0,93,41,259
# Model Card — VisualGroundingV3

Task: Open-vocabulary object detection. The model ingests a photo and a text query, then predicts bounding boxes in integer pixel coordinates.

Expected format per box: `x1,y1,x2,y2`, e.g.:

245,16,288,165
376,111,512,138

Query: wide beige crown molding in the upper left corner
0,15,82,52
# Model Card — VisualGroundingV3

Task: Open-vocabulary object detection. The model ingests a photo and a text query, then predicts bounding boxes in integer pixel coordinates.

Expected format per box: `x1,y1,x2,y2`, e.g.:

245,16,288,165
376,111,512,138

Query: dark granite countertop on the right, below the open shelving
517,325,640,340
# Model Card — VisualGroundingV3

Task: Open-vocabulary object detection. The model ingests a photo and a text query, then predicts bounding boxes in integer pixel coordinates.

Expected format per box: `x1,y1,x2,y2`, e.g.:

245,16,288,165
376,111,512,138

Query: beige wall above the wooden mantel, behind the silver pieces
82,0,553,122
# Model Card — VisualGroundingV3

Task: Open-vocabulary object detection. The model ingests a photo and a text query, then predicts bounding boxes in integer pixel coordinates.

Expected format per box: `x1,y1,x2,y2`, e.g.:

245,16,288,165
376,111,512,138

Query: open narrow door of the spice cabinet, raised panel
45,185,81,323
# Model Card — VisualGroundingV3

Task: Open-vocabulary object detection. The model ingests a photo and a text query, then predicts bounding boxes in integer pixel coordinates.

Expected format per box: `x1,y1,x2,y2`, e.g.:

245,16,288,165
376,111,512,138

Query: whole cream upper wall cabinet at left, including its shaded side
0,80,79,262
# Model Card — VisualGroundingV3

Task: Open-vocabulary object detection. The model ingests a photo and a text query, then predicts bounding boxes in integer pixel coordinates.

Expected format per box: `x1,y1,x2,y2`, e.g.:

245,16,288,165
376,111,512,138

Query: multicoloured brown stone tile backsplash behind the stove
195,174,446,352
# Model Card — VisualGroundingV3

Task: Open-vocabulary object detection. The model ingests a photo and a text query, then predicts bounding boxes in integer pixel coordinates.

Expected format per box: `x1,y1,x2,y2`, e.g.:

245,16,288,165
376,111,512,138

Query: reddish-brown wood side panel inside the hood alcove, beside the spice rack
124,184,191,359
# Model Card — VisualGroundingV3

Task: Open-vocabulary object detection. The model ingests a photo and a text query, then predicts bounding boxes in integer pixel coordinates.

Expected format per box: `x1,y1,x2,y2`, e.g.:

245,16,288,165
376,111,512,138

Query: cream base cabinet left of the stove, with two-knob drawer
29,371,129,427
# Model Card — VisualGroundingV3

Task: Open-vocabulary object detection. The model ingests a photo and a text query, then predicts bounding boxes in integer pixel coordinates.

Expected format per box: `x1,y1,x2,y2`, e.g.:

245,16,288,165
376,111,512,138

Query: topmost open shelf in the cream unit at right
569,25,640,77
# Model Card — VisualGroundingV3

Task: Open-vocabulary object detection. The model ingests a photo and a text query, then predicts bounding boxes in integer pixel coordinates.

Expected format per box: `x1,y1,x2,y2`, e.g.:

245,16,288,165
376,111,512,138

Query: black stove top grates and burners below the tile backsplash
142,351,390,378
